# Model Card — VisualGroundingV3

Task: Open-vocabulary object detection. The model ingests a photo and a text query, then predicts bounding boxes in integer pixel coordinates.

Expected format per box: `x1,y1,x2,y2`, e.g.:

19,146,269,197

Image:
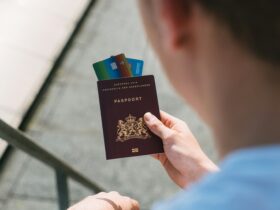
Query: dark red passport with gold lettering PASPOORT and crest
97,75,163,159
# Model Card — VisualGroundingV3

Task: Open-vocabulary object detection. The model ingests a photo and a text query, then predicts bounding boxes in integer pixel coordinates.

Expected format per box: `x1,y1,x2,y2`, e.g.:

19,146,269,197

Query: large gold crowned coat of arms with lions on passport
116,114,151,142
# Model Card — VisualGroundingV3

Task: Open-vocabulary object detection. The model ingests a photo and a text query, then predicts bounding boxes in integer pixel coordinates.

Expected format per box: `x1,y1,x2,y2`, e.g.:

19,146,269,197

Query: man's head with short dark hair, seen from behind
139,0,280,156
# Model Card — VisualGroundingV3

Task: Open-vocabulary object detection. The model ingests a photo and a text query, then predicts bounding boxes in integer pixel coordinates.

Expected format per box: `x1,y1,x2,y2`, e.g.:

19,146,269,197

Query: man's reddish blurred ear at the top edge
157,0,191,51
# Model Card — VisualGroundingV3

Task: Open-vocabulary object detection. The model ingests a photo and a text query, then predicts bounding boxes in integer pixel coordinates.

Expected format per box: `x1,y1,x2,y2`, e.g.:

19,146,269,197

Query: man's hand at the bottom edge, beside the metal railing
68,192,140,210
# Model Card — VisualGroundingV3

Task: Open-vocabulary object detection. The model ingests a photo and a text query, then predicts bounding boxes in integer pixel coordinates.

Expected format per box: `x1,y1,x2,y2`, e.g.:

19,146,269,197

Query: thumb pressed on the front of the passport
144,112,173,140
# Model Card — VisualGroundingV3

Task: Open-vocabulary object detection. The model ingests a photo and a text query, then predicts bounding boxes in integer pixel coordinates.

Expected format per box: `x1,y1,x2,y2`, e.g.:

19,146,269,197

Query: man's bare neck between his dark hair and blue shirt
213,53,280,157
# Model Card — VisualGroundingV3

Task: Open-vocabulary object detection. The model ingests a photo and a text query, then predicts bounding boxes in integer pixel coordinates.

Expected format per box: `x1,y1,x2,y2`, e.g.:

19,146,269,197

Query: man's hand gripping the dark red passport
144,111,219,188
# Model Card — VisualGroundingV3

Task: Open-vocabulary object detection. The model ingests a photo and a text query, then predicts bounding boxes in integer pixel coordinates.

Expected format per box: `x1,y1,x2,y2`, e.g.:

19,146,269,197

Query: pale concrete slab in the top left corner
0,0,90,158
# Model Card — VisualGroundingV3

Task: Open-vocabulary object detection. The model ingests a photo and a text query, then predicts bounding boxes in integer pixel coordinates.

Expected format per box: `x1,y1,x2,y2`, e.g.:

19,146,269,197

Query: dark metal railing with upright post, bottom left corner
0,119,104,210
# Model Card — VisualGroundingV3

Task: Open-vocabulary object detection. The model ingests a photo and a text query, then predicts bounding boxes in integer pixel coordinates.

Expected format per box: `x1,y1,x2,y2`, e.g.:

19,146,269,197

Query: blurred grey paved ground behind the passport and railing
0,0,215,210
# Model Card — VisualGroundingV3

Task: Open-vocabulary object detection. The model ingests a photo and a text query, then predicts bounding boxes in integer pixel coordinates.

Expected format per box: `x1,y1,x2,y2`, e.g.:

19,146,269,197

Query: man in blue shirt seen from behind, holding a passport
70,0,280,210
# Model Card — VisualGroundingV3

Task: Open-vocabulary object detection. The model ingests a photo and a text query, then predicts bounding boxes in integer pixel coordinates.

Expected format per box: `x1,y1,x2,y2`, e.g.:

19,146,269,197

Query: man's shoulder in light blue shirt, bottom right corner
155,147,280,210
